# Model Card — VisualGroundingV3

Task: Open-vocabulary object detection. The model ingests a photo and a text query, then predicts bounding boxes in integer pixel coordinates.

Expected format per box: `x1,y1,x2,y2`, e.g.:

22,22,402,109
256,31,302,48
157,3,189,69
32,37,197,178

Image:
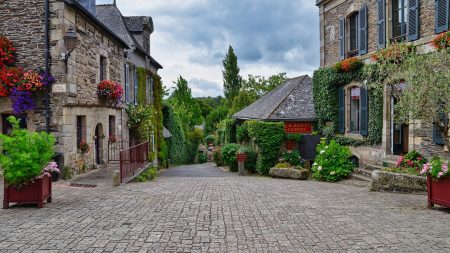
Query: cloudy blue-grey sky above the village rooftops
97,0,320,96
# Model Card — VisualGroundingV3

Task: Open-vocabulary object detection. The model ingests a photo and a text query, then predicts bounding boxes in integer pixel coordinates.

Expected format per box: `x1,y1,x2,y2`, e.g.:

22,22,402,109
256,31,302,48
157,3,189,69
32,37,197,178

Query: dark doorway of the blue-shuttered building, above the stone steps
391,96,409,155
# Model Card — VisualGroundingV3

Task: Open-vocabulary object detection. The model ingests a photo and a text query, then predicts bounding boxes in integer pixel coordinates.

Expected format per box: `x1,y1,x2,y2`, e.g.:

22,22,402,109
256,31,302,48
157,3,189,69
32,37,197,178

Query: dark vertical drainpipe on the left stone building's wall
44,0,52,133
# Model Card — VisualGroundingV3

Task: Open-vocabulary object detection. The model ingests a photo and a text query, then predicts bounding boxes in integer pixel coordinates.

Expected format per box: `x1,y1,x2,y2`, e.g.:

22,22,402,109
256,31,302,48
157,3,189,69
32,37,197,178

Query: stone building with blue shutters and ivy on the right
316,0,449,163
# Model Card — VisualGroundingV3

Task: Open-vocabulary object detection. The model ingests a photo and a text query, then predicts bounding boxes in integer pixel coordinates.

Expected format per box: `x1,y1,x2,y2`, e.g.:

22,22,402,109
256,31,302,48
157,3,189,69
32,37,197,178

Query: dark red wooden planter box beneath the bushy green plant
3,176,52,209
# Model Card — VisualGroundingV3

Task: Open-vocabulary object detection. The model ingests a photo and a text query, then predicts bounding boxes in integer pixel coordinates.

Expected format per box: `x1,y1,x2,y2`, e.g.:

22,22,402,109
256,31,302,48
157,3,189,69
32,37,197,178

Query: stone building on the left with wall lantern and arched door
0,0,161,172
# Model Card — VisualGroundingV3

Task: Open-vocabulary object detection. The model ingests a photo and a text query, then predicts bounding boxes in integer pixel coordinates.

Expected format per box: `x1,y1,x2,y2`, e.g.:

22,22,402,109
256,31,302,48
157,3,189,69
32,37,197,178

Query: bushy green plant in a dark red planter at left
0,116,59,208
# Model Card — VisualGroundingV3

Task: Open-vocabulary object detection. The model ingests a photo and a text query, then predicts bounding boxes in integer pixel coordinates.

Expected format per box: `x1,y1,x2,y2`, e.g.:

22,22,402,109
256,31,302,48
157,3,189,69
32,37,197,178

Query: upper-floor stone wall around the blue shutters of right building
320,0,442,66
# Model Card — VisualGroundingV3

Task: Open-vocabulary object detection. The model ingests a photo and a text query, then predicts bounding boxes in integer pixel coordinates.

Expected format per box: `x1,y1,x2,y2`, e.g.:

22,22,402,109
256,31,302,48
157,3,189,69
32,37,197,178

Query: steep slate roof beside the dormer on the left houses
96,4,163,69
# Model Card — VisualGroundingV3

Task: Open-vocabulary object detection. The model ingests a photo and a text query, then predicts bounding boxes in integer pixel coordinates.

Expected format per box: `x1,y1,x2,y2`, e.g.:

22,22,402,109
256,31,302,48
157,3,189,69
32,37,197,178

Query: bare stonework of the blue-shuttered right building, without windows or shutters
316,0,448,163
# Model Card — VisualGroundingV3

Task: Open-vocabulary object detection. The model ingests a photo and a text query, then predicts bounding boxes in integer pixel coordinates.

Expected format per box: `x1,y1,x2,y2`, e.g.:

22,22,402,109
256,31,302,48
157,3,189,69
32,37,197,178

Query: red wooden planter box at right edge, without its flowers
427,176,450,208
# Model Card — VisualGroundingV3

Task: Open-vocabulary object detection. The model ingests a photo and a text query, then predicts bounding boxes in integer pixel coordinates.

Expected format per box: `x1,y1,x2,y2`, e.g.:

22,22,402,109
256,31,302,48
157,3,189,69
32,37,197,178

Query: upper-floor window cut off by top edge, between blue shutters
392,0,408,41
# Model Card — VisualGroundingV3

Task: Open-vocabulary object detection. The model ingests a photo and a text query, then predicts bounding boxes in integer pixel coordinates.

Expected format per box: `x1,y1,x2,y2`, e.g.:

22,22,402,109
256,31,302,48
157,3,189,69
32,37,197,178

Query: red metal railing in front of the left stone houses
120,142,148,183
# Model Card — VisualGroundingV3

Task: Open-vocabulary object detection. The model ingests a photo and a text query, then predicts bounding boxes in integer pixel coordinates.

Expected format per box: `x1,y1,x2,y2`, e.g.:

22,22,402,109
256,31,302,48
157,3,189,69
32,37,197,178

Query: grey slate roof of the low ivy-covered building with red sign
233,75,317,121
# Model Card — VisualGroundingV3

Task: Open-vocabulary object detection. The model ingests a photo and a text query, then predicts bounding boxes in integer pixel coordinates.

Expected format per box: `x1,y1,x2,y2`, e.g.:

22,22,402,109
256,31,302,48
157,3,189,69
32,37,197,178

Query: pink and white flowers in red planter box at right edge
420,158,450,208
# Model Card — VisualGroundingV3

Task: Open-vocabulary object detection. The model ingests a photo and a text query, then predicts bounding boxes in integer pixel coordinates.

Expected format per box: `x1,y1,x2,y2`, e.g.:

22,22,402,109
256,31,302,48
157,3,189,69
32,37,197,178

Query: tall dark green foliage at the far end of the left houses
163,104,185,164
